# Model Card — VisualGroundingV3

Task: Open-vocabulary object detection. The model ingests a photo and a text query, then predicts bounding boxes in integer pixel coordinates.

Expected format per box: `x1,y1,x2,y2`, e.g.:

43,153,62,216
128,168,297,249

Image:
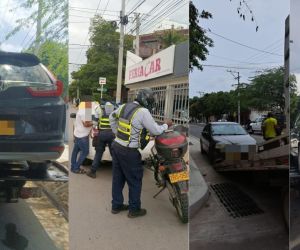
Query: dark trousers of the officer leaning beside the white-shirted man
91,130,115,172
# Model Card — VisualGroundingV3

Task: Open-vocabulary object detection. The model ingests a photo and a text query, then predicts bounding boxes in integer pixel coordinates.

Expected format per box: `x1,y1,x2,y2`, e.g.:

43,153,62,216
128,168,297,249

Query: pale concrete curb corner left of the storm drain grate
189,136,210,218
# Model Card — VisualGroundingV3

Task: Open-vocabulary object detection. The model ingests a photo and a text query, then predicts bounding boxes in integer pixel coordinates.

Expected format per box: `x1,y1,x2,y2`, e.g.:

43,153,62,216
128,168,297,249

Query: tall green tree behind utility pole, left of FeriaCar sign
69,15,133,99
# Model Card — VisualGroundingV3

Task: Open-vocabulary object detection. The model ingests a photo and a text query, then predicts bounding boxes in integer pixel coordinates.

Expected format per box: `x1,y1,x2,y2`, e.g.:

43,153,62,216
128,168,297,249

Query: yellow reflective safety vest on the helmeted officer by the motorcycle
117,102,150,149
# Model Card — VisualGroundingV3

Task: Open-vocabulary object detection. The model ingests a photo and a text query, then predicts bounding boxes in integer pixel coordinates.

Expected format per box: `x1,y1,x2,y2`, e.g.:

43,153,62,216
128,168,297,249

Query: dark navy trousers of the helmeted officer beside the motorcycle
111,142,144,211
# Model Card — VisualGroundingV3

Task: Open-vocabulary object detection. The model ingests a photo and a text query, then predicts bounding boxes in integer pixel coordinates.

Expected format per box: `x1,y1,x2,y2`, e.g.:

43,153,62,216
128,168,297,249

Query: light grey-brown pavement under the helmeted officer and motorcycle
69,107,189,250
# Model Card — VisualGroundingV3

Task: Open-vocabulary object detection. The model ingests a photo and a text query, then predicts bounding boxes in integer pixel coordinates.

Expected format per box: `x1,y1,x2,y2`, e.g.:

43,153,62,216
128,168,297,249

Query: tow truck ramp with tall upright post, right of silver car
209,18,290,225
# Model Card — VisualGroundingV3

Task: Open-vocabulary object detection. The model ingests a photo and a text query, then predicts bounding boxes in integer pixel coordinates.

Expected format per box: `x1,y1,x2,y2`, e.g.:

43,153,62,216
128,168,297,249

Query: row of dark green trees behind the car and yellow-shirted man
190,67,292,121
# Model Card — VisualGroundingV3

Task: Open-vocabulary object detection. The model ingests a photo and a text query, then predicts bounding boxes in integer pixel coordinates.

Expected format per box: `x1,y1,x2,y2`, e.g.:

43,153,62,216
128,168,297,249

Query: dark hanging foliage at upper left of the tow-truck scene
189,1,213,71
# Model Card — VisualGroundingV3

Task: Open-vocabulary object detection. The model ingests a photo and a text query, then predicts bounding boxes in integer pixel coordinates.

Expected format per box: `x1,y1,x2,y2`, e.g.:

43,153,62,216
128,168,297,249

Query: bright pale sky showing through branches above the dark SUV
5,0,68,47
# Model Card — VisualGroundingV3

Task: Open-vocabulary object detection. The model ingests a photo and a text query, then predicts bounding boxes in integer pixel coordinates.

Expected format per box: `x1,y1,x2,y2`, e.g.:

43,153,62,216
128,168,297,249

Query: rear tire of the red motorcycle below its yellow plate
171,184,189,223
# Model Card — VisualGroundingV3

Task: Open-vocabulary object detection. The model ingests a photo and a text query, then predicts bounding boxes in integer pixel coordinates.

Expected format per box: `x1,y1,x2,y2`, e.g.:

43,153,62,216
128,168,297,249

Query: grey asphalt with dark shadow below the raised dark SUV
0,200,57,250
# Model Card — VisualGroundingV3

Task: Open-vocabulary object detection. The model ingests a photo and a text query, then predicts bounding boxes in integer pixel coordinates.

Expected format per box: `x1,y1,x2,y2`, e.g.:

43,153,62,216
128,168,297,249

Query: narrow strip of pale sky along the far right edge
290,0,300,93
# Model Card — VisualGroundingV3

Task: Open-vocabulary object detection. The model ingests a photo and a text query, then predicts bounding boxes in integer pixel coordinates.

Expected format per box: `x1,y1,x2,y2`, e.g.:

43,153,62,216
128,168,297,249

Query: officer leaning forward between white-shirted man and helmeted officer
86,102,115,178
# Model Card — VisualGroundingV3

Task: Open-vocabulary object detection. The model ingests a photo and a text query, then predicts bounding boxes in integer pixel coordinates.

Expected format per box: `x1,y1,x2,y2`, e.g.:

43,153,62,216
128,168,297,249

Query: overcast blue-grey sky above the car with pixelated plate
190,0,290,97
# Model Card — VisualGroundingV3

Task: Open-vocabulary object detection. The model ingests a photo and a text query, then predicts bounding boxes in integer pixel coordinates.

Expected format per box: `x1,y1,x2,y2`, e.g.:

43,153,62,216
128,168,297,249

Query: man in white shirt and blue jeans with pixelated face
71,103,93,174
